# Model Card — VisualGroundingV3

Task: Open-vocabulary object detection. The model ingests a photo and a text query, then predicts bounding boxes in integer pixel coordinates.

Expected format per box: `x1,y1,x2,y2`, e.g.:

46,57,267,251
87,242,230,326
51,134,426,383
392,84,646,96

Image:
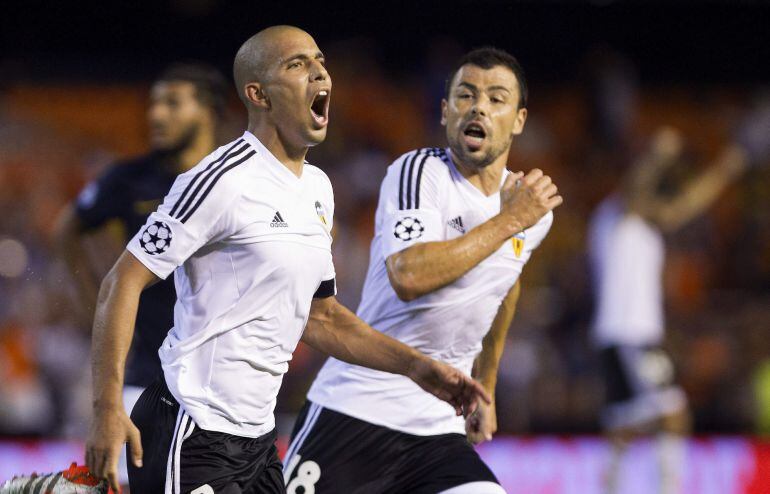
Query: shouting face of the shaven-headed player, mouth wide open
262,31,332,147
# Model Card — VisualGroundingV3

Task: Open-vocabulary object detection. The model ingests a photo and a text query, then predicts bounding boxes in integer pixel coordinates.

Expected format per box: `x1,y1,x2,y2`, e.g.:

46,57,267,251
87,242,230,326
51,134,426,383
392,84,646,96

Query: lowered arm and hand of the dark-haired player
465,281,521,444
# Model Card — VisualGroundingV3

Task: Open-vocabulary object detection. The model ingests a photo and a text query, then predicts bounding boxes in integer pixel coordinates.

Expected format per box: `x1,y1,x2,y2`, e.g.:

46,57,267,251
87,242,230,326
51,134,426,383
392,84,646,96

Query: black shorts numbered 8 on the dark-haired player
284,402,504,494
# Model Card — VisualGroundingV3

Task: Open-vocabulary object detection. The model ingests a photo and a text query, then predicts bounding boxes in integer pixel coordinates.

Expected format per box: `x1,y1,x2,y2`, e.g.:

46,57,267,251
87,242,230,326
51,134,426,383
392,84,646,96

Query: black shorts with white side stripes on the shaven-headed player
128,378,286,494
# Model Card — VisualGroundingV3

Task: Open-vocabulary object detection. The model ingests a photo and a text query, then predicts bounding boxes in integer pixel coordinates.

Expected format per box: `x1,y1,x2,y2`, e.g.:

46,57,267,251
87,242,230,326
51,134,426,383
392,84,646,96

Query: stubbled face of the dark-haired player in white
441,65,527,168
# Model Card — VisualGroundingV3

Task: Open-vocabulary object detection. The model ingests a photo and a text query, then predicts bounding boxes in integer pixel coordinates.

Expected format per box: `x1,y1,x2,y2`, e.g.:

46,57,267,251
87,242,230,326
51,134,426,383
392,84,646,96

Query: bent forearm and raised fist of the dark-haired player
386,169,562,301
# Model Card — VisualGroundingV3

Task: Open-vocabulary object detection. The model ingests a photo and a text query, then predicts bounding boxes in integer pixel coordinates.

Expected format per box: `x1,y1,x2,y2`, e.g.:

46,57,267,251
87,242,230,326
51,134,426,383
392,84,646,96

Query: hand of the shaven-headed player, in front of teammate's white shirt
407,355,492,417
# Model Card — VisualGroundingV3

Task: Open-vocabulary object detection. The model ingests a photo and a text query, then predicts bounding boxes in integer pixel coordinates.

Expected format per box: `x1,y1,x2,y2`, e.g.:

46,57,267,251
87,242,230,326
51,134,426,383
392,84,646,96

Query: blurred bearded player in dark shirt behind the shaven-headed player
57,63,228,485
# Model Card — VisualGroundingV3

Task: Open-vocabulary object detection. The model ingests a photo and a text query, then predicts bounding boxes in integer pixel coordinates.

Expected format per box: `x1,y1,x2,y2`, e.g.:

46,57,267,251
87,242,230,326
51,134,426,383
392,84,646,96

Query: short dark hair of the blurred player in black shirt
155,62,230,118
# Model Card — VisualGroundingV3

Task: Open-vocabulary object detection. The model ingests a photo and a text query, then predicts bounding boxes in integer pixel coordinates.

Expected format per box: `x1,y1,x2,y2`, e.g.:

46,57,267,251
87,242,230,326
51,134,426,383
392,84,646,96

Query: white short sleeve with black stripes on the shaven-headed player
126,170,240,279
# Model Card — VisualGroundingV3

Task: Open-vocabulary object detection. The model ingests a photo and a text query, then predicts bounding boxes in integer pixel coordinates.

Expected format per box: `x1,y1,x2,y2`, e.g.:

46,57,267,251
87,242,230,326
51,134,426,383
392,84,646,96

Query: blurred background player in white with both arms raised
588,128,760,494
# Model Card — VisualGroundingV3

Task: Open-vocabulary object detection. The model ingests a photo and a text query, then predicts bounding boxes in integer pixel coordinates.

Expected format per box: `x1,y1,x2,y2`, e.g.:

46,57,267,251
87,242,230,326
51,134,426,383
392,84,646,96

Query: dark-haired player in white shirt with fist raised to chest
284,48,562,494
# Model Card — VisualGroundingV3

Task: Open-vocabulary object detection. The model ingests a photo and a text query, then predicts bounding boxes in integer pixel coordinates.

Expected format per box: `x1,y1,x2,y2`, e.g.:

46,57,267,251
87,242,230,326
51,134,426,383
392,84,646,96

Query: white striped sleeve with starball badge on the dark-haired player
377,150,445,259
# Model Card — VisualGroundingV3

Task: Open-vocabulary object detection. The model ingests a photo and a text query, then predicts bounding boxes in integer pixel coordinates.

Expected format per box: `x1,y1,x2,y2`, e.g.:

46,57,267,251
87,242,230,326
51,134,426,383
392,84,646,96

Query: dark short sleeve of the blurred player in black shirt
75,165,126,230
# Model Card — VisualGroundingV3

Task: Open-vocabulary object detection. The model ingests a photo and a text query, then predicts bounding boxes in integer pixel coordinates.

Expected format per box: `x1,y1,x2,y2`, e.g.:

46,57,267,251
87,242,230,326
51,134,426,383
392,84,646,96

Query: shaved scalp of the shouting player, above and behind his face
233,26,312,105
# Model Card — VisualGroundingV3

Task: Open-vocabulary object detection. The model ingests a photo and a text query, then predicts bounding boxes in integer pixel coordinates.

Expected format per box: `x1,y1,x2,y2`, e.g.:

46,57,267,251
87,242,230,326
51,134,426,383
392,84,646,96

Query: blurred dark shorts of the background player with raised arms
600,345,687,429
